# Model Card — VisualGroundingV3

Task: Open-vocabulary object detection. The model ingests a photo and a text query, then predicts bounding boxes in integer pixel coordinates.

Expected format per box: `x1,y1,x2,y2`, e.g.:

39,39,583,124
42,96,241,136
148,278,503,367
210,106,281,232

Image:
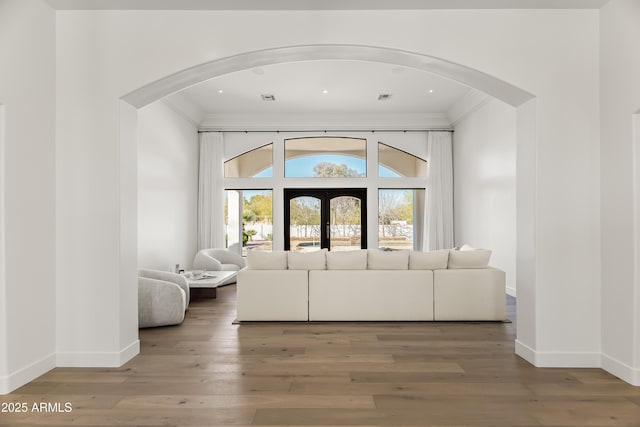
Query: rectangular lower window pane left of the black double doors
224,190,273,256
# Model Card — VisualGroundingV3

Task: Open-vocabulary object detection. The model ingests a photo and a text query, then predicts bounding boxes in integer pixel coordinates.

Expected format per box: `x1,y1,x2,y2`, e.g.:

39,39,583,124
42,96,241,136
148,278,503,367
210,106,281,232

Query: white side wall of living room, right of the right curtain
453,99,516,296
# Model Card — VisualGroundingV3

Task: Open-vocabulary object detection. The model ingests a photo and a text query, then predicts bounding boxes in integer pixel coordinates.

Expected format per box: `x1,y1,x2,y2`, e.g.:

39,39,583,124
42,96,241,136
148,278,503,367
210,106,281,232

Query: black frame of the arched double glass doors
283,188,367,251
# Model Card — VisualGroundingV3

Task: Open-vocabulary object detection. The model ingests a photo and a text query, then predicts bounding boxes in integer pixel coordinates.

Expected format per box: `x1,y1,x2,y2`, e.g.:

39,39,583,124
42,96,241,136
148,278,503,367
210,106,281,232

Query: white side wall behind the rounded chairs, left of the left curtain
138,101,198,271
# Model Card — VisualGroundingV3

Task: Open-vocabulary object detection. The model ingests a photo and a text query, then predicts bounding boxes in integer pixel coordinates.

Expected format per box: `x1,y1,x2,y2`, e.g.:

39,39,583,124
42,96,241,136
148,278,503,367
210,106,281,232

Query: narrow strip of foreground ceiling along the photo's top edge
47,0,609,10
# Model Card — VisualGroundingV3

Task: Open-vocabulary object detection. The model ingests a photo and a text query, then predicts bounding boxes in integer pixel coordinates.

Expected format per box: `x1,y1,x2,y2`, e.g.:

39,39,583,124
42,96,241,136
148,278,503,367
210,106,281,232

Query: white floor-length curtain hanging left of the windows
198,132,225,250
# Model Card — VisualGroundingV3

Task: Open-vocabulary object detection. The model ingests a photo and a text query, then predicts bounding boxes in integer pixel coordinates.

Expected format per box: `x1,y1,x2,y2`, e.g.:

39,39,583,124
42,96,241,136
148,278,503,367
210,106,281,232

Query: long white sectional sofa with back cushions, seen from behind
237,247,505,321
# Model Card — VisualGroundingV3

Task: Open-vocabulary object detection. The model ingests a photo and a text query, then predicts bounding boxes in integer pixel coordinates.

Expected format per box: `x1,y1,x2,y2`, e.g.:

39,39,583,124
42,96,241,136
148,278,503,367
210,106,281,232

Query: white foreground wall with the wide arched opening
52,10,601,378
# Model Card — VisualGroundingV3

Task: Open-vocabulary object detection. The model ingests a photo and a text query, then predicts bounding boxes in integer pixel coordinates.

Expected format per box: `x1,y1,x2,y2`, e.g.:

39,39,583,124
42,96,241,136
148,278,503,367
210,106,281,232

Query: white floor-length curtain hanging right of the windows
423,131,453,251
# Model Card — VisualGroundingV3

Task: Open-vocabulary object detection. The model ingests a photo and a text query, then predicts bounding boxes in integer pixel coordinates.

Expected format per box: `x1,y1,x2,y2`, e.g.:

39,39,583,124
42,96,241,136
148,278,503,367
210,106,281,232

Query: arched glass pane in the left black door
289,196,320,252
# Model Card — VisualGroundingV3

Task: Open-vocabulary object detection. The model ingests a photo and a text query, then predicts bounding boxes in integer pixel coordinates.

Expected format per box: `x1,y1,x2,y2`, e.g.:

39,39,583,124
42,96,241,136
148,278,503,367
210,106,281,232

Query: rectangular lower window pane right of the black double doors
378,189,424,249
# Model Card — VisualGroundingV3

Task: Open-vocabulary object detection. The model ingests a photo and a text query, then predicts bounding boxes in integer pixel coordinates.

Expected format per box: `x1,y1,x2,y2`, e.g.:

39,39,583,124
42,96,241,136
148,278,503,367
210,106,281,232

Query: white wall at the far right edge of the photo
600,0,640,385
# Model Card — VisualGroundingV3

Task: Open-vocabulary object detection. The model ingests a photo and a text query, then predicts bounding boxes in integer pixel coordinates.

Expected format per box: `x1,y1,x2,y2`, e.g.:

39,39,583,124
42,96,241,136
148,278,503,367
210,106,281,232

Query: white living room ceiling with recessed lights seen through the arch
164,60,489,130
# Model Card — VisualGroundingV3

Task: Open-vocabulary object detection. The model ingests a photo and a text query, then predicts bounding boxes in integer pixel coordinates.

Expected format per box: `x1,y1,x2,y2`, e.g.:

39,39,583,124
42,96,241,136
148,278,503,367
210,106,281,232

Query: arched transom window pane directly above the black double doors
284,137,367,178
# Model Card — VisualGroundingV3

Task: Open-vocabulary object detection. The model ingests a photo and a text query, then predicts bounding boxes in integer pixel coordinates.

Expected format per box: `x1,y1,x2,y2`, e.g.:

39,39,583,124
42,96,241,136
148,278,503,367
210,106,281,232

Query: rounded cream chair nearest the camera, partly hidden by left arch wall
138,269,189,328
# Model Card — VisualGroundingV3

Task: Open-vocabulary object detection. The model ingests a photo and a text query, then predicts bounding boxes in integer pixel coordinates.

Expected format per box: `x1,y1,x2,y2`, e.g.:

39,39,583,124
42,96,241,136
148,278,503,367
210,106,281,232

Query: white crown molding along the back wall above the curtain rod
200,113,451,131
